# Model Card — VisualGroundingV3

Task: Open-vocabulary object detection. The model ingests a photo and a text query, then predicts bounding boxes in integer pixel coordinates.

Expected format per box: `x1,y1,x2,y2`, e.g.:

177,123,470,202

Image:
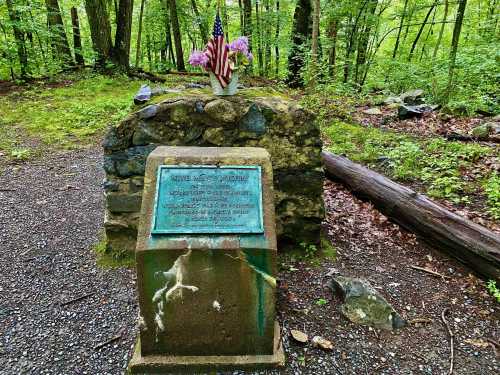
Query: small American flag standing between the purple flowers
207,13,231,88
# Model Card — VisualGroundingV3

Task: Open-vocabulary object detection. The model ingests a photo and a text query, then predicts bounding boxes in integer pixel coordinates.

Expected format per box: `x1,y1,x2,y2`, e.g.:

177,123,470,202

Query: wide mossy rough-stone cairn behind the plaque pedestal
104,89,324,253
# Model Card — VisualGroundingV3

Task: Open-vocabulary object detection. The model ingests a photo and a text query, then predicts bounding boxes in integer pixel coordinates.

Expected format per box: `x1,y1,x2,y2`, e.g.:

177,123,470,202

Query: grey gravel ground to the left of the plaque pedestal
0,149,137,374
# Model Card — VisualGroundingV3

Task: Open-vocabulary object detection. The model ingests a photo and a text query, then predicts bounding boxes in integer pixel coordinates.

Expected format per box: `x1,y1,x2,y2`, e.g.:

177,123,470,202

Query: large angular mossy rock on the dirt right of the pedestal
330,276,406,330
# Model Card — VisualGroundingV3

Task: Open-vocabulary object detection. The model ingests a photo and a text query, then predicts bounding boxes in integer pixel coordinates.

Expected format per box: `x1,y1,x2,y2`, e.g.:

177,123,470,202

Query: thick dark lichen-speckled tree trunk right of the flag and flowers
287,0,312,88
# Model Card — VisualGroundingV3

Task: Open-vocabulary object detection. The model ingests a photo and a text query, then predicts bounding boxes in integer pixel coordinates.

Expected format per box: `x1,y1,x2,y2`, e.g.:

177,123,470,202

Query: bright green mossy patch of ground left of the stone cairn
0,73,141,159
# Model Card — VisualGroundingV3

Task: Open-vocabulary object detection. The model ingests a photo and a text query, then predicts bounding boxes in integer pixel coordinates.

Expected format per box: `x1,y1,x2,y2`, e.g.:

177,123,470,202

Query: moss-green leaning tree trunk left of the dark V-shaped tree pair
45,0,73,64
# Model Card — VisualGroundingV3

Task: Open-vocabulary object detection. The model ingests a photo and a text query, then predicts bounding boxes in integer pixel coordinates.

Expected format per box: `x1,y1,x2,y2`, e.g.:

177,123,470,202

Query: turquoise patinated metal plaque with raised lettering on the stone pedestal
151,165,264,234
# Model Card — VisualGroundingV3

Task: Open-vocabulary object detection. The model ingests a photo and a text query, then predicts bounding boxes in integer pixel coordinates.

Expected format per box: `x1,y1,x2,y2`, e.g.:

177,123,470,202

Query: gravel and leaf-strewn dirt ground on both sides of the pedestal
0,149,500,375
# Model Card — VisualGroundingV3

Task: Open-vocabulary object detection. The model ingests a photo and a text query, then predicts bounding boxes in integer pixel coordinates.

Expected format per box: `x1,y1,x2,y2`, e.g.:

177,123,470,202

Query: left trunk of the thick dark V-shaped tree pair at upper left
85,0,113,66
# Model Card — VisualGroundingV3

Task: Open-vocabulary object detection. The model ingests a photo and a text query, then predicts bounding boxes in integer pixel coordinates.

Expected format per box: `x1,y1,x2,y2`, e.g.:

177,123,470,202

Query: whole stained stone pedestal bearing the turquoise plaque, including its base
129,146,284,373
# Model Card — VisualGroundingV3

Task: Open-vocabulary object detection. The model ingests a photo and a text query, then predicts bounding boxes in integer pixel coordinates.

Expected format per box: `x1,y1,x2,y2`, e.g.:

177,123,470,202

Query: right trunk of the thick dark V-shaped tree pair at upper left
112,0,134,70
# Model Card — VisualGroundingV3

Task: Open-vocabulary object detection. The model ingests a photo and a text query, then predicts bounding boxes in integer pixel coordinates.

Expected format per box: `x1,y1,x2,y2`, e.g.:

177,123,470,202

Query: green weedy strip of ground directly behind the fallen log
322,120,500,219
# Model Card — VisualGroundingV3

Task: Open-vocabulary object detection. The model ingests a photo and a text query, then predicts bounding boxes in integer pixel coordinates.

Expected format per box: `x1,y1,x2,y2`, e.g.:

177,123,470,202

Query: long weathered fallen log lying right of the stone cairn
322,151,500,282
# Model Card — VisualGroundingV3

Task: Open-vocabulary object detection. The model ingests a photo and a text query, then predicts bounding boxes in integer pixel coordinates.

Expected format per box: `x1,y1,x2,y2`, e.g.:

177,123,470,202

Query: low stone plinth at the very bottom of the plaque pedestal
129,322,285,374
